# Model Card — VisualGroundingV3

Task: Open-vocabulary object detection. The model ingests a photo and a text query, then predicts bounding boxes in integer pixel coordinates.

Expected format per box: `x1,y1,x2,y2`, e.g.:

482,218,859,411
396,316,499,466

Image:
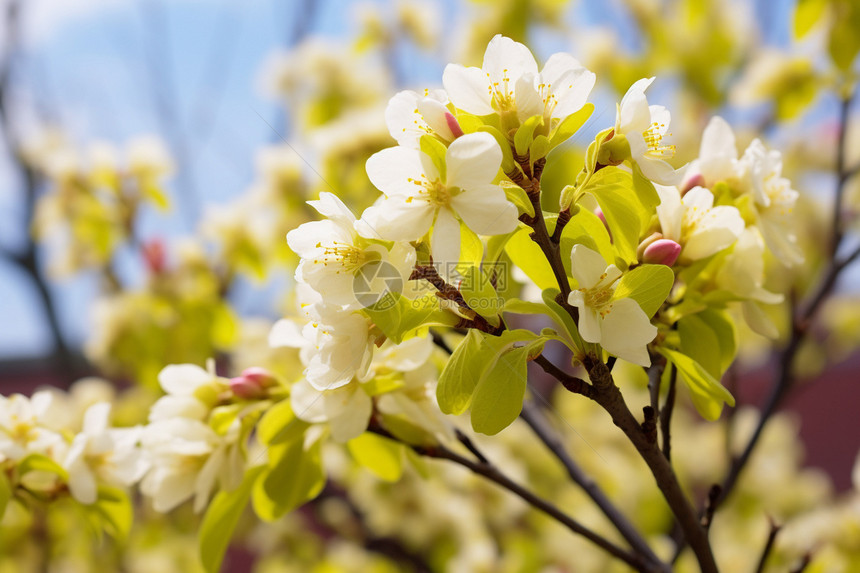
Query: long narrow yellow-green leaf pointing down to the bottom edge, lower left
197,466,266,573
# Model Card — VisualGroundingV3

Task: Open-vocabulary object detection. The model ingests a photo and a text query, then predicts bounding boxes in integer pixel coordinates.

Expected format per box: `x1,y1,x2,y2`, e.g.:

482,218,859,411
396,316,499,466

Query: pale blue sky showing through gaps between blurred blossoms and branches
0,0,820,357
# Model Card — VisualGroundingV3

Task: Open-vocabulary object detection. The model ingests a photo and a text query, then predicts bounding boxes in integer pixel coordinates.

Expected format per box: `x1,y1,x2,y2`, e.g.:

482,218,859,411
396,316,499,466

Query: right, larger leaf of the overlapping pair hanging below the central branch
471,346,529,436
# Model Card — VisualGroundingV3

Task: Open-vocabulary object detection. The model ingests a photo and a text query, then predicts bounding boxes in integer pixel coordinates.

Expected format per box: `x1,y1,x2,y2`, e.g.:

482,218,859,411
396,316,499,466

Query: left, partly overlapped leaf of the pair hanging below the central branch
436,330,492,416
